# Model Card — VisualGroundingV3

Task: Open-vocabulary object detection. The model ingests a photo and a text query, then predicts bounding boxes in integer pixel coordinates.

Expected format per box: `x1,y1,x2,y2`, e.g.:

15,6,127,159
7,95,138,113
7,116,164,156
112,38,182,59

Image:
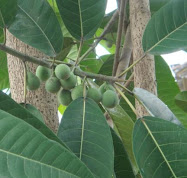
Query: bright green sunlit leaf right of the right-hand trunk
155,56,187,127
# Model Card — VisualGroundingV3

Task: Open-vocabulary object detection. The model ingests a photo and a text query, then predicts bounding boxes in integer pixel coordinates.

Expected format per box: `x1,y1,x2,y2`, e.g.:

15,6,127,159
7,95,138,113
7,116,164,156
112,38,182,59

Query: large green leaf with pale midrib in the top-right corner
143,0,187,55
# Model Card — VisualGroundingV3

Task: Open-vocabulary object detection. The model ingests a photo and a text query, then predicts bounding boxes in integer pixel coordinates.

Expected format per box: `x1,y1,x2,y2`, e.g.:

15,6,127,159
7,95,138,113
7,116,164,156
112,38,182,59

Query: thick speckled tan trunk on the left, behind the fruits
6,32,59,132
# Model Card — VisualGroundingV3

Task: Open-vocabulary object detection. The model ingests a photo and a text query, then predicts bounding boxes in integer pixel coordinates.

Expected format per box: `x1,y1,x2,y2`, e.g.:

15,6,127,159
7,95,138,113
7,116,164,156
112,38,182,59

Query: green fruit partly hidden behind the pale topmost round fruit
60,73,77,90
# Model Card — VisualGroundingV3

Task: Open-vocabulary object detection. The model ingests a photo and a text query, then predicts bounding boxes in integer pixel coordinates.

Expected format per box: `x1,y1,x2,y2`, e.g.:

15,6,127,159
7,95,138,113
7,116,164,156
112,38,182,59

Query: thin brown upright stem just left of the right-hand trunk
112,0,127,76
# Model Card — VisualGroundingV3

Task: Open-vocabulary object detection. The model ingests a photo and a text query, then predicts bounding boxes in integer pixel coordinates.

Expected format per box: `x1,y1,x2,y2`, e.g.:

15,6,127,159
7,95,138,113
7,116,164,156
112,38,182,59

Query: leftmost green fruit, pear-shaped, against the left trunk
27,71,40,90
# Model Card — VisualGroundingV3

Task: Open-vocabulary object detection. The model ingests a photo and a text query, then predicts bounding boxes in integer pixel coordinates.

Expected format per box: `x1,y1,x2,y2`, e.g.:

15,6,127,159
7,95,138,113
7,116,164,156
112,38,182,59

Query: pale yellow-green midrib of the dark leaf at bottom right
141,119,177,178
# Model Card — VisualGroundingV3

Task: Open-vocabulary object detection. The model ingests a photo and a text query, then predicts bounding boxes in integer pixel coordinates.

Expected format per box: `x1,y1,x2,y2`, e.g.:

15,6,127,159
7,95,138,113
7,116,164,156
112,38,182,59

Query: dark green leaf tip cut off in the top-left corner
0,0,17,28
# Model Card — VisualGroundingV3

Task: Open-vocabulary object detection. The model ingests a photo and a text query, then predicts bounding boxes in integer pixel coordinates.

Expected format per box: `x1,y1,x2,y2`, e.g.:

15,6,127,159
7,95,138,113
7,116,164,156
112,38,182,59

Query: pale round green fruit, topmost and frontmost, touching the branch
55,64,71,80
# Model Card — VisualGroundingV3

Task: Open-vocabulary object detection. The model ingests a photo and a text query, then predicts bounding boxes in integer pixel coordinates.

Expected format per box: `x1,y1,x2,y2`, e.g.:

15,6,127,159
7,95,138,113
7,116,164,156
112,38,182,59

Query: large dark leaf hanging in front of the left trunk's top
8,0,63,57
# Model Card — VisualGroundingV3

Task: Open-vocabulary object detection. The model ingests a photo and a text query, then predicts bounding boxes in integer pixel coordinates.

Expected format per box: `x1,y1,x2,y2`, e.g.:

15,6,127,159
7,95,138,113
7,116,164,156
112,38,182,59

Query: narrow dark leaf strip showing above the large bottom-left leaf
0,91,66,147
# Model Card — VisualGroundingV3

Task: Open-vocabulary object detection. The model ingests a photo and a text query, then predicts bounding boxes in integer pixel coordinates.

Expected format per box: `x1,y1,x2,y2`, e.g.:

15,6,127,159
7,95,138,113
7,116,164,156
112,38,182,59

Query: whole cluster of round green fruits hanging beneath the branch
27,64,118,108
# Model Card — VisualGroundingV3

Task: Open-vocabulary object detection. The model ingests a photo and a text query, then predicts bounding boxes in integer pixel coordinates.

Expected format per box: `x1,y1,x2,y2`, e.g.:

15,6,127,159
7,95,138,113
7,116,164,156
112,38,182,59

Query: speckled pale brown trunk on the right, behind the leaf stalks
130,0,157,116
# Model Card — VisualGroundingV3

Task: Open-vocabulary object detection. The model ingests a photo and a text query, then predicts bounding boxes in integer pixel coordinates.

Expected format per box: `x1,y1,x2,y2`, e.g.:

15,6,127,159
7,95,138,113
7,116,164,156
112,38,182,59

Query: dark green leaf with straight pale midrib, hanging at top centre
56,0,107,40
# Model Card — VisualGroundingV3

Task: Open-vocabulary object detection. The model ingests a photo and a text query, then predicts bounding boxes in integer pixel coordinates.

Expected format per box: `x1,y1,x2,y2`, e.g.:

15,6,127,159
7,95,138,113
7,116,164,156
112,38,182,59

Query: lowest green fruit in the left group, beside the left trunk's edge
58,90,72,106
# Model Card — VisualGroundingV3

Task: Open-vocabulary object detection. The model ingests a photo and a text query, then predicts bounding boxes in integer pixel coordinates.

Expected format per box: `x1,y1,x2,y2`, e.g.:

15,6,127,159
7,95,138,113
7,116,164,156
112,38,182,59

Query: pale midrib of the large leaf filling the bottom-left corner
0,149,79,176
